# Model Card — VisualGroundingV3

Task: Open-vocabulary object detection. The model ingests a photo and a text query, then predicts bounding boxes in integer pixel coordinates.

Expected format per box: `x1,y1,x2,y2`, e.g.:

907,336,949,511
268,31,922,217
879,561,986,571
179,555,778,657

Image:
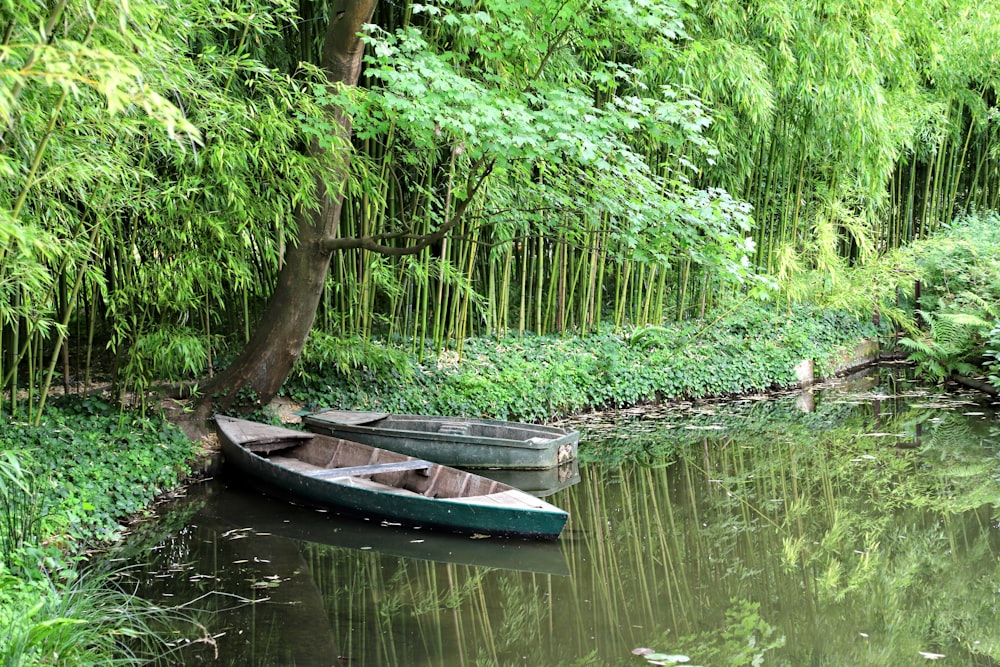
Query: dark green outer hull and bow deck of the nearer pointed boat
216,417,569,539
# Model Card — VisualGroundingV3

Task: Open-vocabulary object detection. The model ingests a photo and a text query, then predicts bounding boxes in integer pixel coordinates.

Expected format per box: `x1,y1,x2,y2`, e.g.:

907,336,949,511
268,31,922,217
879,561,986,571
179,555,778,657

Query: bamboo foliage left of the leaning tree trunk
0,0,327,420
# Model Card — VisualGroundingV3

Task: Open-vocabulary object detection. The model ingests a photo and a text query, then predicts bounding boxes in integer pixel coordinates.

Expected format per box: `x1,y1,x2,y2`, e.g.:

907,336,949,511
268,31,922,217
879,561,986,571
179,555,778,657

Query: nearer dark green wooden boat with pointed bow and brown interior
215,416,569,539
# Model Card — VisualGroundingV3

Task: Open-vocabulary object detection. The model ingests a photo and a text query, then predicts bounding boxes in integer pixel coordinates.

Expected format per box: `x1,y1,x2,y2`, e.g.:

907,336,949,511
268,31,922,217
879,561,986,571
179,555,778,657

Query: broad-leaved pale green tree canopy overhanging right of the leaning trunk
352,0,750,288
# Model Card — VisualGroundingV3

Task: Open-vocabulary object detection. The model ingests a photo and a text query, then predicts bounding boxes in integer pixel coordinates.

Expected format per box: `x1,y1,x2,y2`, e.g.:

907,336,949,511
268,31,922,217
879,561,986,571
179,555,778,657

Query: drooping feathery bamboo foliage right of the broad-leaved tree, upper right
677,0,1000,306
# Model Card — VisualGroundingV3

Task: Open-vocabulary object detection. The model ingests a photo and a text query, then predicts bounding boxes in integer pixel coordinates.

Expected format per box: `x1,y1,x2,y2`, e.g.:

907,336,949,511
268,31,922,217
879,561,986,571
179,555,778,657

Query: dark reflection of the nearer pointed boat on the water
190,480,569,576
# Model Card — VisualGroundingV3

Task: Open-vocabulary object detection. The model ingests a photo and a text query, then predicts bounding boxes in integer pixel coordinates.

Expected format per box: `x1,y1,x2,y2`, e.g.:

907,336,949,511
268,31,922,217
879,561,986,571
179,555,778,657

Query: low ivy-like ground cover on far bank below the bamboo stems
286,305,877,421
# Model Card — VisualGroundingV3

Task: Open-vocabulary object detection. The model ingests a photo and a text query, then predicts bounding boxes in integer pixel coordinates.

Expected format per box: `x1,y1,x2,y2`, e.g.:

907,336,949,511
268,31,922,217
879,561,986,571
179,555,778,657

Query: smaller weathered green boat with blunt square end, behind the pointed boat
303,410,580,470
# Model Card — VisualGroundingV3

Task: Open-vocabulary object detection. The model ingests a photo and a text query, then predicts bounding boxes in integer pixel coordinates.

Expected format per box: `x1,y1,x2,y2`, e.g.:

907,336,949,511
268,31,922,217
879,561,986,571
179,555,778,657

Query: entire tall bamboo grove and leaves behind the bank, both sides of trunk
0,0,1000,413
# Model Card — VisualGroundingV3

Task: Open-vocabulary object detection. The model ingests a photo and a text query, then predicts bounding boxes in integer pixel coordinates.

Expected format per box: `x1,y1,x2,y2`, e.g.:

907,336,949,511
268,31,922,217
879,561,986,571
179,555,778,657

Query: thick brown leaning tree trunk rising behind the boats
195,0,377,419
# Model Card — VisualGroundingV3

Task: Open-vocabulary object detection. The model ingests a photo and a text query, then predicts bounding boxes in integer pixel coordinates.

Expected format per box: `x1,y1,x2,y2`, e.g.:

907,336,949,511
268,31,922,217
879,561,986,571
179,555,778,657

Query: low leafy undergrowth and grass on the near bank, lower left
0,398,193,666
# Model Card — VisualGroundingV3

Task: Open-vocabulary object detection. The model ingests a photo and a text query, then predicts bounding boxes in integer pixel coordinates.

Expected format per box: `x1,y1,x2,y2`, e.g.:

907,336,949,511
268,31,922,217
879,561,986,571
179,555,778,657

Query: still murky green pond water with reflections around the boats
121,369,1000,667
